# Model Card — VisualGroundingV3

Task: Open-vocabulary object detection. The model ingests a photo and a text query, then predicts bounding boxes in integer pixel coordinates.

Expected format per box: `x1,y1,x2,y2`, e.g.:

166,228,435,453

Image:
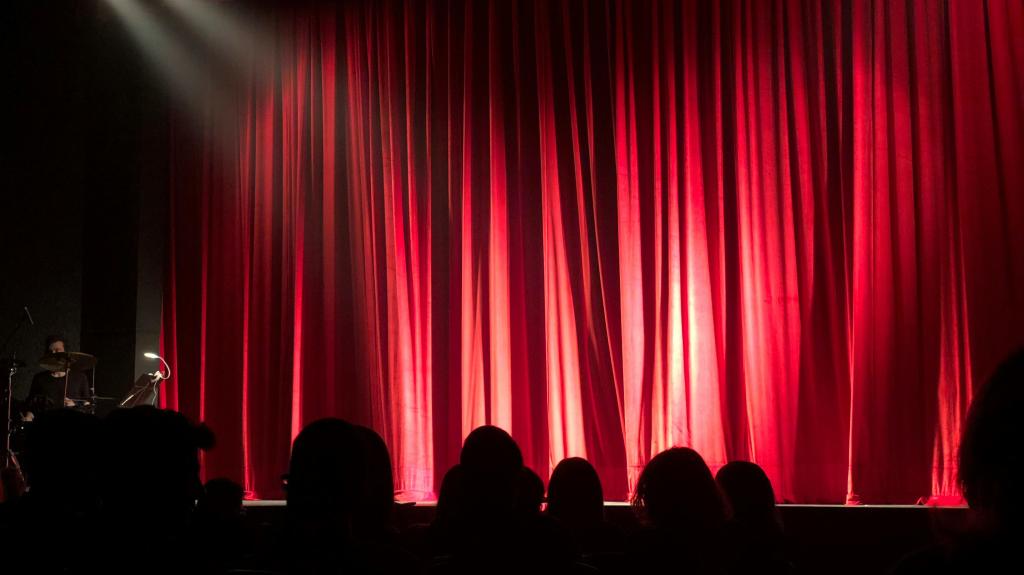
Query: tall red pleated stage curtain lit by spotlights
163,0,1024,502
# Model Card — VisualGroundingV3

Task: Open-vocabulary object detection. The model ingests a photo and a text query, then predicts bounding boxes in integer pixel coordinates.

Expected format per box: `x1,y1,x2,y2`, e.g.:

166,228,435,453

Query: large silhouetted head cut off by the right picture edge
959,349,1024,525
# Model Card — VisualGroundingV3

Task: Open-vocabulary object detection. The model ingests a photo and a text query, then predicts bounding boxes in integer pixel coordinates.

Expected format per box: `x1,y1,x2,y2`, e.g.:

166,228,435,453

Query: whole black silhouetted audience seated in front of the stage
0,351,1024,575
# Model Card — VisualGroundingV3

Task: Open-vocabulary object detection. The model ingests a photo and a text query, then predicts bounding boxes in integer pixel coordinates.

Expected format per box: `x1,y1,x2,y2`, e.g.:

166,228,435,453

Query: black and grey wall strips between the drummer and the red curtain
82,0,167,407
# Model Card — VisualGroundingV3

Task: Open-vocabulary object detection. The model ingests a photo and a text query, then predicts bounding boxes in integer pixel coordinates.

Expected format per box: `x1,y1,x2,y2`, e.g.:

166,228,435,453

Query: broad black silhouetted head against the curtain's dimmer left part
288,417,368,526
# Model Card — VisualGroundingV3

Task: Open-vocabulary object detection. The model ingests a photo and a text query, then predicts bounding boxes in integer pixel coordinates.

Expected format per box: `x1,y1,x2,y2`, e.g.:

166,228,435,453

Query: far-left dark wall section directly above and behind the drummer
0,0,88,396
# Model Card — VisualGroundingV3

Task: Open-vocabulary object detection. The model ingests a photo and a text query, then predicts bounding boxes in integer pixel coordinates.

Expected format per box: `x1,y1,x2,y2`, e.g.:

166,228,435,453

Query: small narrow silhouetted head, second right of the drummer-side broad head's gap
548,457,604,527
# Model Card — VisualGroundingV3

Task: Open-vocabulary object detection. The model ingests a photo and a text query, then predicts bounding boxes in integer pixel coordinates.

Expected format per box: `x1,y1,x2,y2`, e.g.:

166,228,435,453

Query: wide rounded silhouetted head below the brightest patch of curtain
633,447,725,533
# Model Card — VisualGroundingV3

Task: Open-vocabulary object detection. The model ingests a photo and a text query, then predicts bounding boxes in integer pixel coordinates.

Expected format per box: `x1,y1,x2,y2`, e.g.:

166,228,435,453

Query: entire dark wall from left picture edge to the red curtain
0,0,166,406
